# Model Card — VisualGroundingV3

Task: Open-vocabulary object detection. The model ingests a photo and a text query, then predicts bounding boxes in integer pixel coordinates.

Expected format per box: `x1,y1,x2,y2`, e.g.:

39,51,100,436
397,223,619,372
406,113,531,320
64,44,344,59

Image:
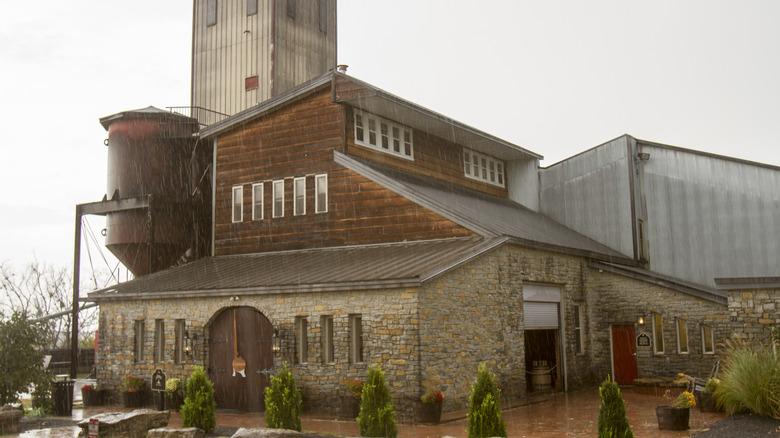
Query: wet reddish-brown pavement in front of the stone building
20,388,725,438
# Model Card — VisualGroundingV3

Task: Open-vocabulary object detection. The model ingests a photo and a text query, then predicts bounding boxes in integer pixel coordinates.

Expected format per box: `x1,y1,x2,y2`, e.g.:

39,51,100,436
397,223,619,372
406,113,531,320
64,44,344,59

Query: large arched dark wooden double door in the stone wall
209,307,274,412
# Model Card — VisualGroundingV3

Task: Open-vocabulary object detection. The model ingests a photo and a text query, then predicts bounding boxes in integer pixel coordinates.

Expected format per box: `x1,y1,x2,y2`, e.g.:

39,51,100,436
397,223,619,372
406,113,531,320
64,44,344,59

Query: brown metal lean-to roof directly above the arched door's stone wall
86,237,505,301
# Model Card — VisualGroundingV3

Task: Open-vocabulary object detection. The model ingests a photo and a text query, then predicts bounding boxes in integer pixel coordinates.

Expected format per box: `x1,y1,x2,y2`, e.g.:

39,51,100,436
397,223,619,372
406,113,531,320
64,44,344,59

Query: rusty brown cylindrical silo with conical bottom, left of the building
100,107,199,276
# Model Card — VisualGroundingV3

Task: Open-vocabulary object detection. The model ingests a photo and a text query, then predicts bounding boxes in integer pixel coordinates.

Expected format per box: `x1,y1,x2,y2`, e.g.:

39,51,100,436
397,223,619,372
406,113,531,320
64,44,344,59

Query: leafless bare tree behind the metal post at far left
0,260,97,348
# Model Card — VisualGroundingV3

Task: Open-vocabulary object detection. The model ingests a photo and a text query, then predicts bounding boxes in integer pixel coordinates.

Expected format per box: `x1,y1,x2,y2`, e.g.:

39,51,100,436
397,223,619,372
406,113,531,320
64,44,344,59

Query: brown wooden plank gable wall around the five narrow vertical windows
215,89,475,255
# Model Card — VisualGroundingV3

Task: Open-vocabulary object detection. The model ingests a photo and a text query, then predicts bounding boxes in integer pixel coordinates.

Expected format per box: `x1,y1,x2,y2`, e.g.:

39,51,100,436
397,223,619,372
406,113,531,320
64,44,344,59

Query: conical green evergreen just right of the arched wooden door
265,362,303,432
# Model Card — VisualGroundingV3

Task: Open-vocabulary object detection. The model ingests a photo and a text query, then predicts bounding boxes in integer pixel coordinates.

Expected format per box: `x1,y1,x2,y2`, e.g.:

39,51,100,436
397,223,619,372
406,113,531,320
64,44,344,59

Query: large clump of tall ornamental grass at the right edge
714,340,780,417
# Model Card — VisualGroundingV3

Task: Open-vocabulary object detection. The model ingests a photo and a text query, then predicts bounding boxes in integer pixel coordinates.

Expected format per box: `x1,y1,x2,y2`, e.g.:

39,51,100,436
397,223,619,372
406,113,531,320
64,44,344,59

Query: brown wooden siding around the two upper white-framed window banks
346,106,508,197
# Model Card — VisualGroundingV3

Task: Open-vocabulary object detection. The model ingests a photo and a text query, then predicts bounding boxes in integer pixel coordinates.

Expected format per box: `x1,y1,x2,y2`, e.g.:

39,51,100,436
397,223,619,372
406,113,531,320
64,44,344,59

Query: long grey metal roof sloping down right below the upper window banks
334,151,637,265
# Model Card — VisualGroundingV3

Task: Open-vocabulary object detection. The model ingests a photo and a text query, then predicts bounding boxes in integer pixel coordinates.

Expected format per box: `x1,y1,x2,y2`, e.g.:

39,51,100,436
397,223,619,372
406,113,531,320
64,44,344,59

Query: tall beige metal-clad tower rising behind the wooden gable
191,0,336,124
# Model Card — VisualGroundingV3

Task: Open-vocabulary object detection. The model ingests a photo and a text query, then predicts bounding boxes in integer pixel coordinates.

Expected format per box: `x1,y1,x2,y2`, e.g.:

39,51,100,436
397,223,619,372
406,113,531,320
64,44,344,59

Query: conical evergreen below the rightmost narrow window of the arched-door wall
357,365,398,437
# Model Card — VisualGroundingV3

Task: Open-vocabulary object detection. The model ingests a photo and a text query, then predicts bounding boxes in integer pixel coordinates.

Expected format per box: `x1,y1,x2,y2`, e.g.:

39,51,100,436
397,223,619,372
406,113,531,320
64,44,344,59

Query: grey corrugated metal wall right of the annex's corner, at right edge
641,144,780,287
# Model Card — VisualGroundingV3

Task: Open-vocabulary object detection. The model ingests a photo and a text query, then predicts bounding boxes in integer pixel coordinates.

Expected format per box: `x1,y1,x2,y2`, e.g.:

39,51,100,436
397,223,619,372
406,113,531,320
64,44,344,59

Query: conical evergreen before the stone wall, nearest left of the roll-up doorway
468,362,506,438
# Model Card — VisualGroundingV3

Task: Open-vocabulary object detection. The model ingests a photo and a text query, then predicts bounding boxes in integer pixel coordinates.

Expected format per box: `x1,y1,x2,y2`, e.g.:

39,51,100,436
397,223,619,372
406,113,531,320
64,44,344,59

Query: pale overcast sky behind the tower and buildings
0,0,780,275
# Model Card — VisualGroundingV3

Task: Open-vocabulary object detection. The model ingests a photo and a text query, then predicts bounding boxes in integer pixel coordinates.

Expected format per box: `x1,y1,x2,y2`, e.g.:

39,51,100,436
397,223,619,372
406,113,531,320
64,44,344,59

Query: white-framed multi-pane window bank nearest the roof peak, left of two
355,110,414,160
